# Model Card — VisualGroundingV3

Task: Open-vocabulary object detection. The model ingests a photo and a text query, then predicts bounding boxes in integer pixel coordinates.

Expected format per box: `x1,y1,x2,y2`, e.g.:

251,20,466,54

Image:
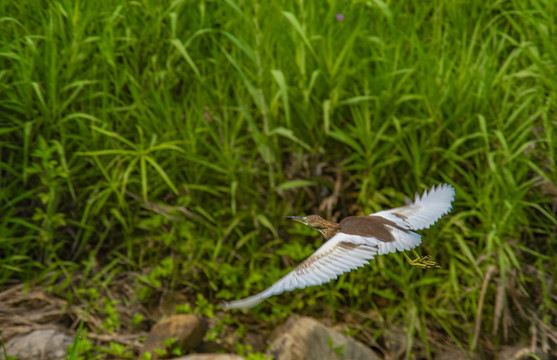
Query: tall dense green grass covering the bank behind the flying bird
0,0,557,357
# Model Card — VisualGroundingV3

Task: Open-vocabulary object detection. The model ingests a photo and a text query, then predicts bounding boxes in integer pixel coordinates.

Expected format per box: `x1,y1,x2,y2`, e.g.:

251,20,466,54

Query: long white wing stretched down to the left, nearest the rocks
221,233,381,309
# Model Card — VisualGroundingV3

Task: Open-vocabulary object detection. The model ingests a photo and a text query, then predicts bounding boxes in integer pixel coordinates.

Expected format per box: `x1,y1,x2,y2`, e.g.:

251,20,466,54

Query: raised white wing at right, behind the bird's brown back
371,184,455,230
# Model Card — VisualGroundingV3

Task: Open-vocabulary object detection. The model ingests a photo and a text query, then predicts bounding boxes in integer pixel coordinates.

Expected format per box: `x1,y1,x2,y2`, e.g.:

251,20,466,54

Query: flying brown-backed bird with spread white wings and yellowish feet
221,184,455,309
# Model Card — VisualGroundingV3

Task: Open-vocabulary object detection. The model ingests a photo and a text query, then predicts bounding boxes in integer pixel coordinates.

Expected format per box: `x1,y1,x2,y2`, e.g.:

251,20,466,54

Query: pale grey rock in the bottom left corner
0,330,74,360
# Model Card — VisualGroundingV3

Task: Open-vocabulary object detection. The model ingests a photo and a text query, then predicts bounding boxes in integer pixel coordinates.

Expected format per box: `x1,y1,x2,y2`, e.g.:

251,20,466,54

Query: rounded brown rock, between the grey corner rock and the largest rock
142,314,207,359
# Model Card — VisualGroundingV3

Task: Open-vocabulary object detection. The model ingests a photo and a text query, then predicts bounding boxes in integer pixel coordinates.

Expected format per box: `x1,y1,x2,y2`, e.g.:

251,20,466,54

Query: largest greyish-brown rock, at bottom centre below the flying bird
269,317,379,360
